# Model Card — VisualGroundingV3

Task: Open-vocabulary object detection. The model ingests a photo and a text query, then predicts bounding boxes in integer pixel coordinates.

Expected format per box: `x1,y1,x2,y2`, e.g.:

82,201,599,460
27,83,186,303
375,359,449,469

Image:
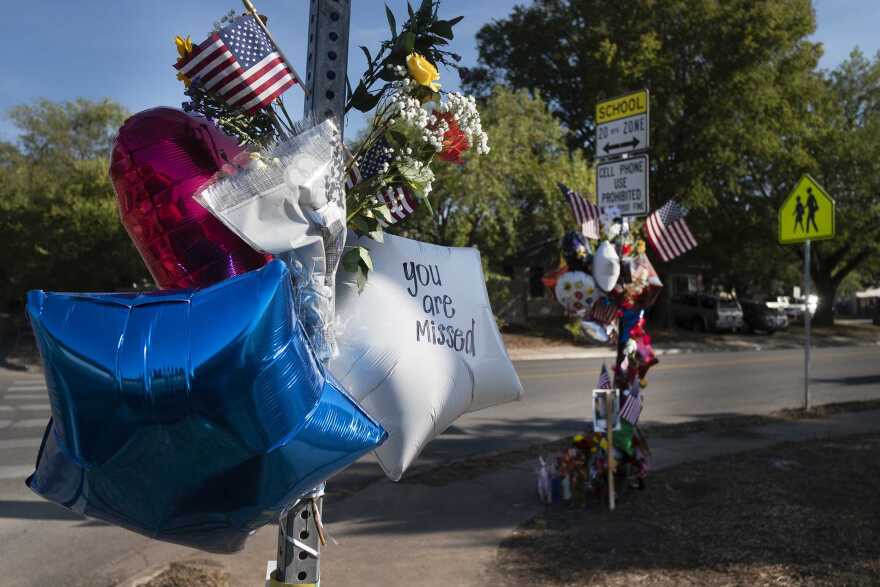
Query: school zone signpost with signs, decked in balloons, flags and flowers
537,90,697,509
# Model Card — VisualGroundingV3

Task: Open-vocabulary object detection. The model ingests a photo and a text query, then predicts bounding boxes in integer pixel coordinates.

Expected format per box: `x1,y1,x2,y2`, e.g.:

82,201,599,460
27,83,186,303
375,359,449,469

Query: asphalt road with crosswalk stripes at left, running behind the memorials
0,347,880,587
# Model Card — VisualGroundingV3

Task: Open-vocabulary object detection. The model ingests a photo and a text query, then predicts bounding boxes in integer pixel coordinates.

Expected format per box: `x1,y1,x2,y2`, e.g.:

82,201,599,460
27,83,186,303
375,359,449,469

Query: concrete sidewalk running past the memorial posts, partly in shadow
108,410,880,587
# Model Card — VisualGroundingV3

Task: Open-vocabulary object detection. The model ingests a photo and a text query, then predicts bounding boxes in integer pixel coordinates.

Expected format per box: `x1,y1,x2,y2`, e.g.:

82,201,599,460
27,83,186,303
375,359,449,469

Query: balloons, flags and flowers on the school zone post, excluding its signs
537,192,695,503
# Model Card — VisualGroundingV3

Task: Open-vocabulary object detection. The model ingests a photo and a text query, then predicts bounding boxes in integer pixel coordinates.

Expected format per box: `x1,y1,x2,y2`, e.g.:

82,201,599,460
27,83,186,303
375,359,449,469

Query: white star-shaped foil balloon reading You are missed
330,235,522,480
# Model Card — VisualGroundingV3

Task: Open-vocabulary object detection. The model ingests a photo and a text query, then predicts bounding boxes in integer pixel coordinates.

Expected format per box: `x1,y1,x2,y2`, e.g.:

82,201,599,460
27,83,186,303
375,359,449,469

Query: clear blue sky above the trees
0,0,880,140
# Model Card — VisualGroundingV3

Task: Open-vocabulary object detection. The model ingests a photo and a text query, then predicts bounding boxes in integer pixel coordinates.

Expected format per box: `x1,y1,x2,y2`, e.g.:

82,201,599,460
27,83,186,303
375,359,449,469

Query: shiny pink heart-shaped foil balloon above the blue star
110,108,271,289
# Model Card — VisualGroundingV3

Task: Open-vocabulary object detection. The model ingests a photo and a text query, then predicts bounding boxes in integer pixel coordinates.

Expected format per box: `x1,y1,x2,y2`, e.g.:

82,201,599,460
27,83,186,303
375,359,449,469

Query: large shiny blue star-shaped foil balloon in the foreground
27,261,386,552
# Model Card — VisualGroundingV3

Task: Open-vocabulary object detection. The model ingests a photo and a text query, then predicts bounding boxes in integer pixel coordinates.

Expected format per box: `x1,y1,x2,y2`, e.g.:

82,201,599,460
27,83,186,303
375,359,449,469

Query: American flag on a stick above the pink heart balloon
174,14,296,112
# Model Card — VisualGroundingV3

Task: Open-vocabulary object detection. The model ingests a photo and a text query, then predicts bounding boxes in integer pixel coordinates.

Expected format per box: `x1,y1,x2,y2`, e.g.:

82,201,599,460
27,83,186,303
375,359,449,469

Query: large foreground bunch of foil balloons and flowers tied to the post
27,2,522,552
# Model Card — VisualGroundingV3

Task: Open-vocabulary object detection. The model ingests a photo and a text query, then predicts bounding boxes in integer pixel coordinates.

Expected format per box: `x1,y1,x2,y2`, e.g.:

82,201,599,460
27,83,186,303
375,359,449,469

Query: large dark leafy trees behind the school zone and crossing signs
467,0,878,324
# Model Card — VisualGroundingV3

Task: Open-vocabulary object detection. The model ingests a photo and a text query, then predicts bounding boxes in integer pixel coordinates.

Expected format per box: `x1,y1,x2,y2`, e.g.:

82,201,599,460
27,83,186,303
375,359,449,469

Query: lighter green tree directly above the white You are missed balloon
392,87,592,302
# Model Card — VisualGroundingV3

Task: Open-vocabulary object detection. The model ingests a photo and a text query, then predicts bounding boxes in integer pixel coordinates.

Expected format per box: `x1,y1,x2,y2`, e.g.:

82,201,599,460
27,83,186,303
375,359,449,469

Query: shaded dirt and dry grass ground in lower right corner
492,434,880,587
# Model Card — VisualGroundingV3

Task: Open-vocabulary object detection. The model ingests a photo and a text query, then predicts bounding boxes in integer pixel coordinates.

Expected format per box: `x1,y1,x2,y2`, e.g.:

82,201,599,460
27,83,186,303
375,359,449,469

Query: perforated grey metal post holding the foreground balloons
269,0,351,587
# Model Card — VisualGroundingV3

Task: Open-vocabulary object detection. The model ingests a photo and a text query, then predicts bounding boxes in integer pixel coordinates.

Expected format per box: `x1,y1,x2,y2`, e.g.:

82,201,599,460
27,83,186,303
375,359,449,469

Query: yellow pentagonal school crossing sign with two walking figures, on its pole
779,175,837,410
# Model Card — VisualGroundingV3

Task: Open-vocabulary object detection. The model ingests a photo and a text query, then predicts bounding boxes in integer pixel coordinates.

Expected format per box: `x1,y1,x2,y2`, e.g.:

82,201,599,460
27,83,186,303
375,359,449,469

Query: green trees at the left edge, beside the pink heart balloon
0,99,146,306
